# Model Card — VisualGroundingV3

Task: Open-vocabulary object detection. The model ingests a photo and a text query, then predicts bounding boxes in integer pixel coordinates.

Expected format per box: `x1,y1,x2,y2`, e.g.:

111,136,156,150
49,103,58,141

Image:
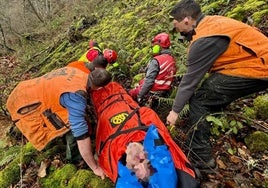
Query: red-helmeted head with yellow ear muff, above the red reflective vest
152,33,171,55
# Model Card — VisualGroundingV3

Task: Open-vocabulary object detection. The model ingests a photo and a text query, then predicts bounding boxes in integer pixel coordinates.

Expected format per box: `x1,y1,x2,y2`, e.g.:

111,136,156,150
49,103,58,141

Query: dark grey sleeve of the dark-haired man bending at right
172,36,229,113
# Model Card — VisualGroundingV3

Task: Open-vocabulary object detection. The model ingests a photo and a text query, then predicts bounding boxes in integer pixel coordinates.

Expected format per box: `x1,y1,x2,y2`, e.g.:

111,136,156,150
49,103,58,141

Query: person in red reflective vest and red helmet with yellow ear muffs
129,33,177,103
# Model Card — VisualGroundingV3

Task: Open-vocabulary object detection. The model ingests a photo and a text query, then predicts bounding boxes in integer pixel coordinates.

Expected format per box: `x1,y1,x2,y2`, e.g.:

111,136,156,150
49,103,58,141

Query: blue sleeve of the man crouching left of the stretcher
60,93,88,138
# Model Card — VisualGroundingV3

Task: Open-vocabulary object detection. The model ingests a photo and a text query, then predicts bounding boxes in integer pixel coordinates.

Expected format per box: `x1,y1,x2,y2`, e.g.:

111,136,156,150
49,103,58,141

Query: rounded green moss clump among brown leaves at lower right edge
245,131,268,152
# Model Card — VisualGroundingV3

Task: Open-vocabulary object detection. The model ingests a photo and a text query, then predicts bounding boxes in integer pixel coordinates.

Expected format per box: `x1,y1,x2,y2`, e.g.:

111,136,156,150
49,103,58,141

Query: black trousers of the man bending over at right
187,73,268,162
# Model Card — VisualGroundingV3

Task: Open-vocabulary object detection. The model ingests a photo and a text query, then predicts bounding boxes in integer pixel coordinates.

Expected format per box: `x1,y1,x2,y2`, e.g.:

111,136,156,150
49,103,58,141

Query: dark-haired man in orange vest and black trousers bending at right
166,0,268,169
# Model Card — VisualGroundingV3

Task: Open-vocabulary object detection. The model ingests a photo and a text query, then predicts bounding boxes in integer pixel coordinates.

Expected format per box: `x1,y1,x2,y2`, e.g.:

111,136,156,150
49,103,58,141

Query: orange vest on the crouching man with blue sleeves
6,67,88,150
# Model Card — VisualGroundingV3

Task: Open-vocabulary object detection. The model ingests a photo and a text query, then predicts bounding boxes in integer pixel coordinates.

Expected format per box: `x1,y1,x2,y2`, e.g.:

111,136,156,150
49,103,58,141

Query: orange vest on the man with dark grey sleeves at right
192,16,268,79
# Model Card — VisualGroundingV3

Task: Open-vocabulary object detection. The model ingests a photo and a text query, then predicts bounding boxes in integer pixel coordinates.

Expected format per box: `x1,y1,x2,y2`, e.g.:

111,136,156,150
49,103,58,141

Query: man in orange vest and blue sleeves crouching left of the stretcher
6,67,111,178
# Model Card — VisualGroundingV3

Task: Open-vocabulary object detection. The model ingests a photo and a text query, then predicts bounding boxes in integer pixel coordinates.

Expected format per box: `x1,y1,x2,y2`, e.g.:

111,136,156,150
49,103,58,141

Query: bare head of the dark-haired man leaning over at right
170,0,201,34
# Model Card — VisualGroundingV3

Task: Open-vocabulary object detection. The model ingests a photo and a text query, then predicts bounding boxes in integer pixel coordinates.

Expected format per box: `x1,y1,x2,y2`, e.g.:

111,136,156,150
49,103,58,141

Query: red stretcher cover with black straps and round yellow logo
92,82,195,182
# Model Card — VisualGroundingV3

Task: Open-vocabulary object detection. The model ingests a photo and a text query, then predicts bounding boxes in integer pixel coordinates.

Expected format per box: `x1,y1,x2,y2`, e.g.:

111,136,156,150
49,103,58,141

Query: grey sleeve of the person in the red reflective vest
138,59,160,98
